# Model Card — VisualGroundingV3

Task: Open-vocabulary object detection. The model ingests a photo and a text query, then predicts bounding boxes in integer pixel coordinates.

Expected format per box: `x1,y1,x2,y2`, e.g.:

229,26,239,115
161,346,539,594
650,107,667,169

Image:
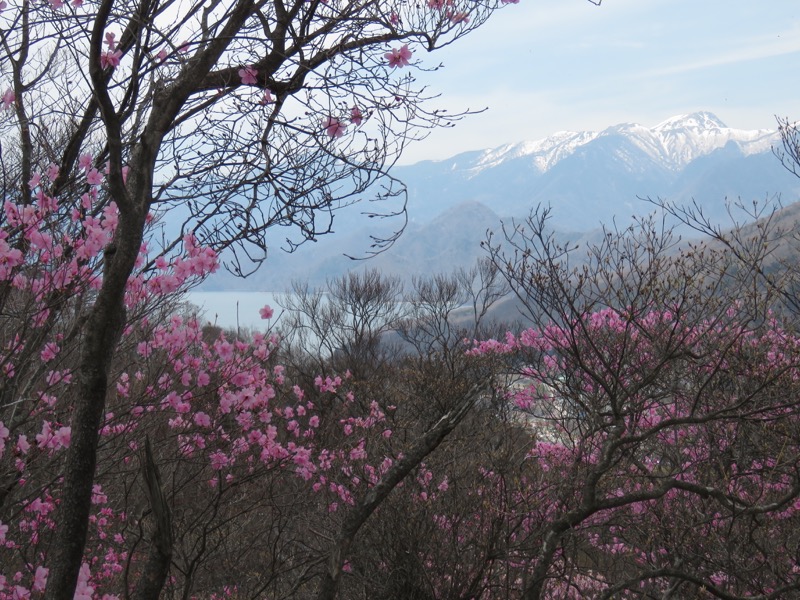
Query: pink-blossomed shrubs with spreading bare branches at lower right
462,306,800,597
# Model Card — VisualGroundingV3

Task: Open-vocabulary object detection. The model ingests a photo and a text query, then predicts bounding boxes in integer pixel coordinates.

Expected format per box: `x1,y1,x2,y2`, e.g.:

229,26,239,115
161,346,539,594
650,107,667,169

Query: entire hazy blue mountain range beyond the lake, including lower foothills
204,112,800,291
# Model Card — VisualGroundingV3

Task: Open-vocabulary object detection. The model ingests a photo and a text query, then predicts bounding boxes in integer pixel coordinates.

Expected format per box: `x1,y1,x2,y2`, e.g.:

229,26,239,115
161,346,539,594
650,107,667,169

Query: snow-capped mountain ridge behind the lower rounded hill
395,112,799,231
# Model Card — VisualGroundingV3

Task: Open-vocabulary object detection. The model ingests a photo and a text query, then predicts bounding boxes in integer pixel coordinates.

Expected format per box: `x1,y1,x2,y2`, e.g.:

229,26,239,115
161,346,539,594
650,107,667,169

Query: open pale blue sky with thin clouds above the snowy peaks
402,0,800,163
